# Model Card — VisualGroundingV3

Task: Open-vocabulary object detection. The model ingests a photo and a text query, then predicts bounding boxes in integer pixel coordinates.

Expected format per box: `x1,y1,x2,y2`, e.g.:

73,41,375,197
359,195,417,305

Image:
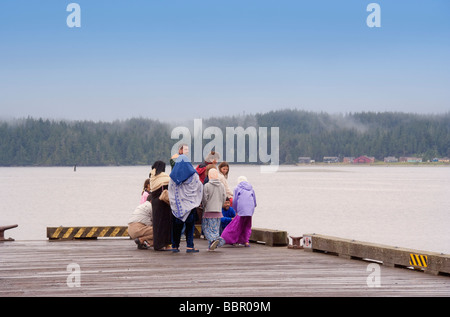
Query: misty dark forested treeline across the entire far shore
0,110,450,166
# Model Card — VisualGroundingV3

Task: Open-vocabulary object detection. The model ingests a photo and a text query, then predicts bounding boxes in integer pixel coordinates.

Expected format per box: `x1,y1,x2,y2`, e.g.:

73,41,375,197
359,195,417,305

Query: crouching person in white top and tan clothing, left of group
128,196,153,250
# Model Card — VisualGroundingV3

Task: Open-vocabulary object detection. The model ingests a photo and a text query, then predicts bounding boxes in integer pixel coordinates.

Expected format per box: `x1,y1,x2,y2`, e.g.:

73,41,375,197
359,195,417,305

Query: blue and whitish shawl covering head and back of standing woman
169,155,203,221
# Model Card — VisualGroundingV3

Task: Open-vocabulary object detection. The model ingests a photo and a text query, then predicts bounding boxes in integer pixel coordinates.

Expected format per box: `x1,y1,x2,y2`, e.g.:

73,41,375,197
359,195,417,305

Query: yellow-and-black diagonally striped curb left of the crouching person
47,226,129,240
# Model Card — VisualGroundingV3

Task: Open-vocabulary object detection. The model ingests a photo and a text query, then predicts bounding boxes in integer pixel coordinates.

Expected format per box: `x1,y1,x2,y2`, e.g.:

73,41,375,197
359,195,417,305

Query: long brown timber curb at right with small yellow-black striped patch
303,234,450,275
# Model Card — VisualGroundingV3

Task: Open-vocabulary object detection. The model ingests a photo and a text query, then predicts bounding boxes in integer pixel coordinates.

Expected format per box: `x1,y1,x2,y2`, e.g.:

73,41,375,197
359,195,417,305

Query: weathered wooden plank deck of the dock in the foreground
0,239,450,297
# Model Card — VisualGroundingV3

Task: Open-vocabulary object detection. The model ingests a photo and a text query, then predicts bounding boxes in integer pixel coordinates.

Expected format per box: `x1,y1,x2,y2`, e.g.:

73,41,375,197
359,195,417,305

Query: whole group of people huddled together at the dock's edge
128,144,256,253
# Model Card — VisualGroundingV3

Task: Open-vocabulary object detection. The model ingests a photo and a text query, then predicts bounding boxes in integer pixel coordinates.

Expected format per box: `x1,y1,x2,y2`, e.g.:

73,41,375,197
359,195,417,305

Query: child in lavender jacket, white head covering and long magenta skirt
222,176,256,247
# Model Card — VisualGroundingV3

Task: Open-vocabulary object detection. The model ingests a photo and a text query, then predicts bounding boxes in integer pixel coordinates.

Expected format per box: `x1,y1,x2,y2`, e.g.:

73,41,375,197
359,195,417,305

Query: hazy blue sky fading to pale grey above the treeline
0,0,450,121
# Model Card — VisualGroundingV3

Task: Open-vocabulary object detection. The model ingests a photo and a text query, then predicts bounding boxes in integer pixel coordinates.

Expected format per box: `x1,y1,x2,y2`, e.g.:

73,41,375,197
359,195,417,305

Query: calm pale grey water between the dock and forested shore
0,165,450,253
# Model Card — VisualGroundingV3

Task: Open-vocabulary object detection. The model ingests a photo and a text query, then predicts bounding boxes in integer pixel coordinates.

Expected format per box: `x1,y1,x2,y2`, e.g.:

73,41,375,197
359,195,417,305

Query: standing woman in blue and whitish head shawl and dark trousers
169,155,203,253
